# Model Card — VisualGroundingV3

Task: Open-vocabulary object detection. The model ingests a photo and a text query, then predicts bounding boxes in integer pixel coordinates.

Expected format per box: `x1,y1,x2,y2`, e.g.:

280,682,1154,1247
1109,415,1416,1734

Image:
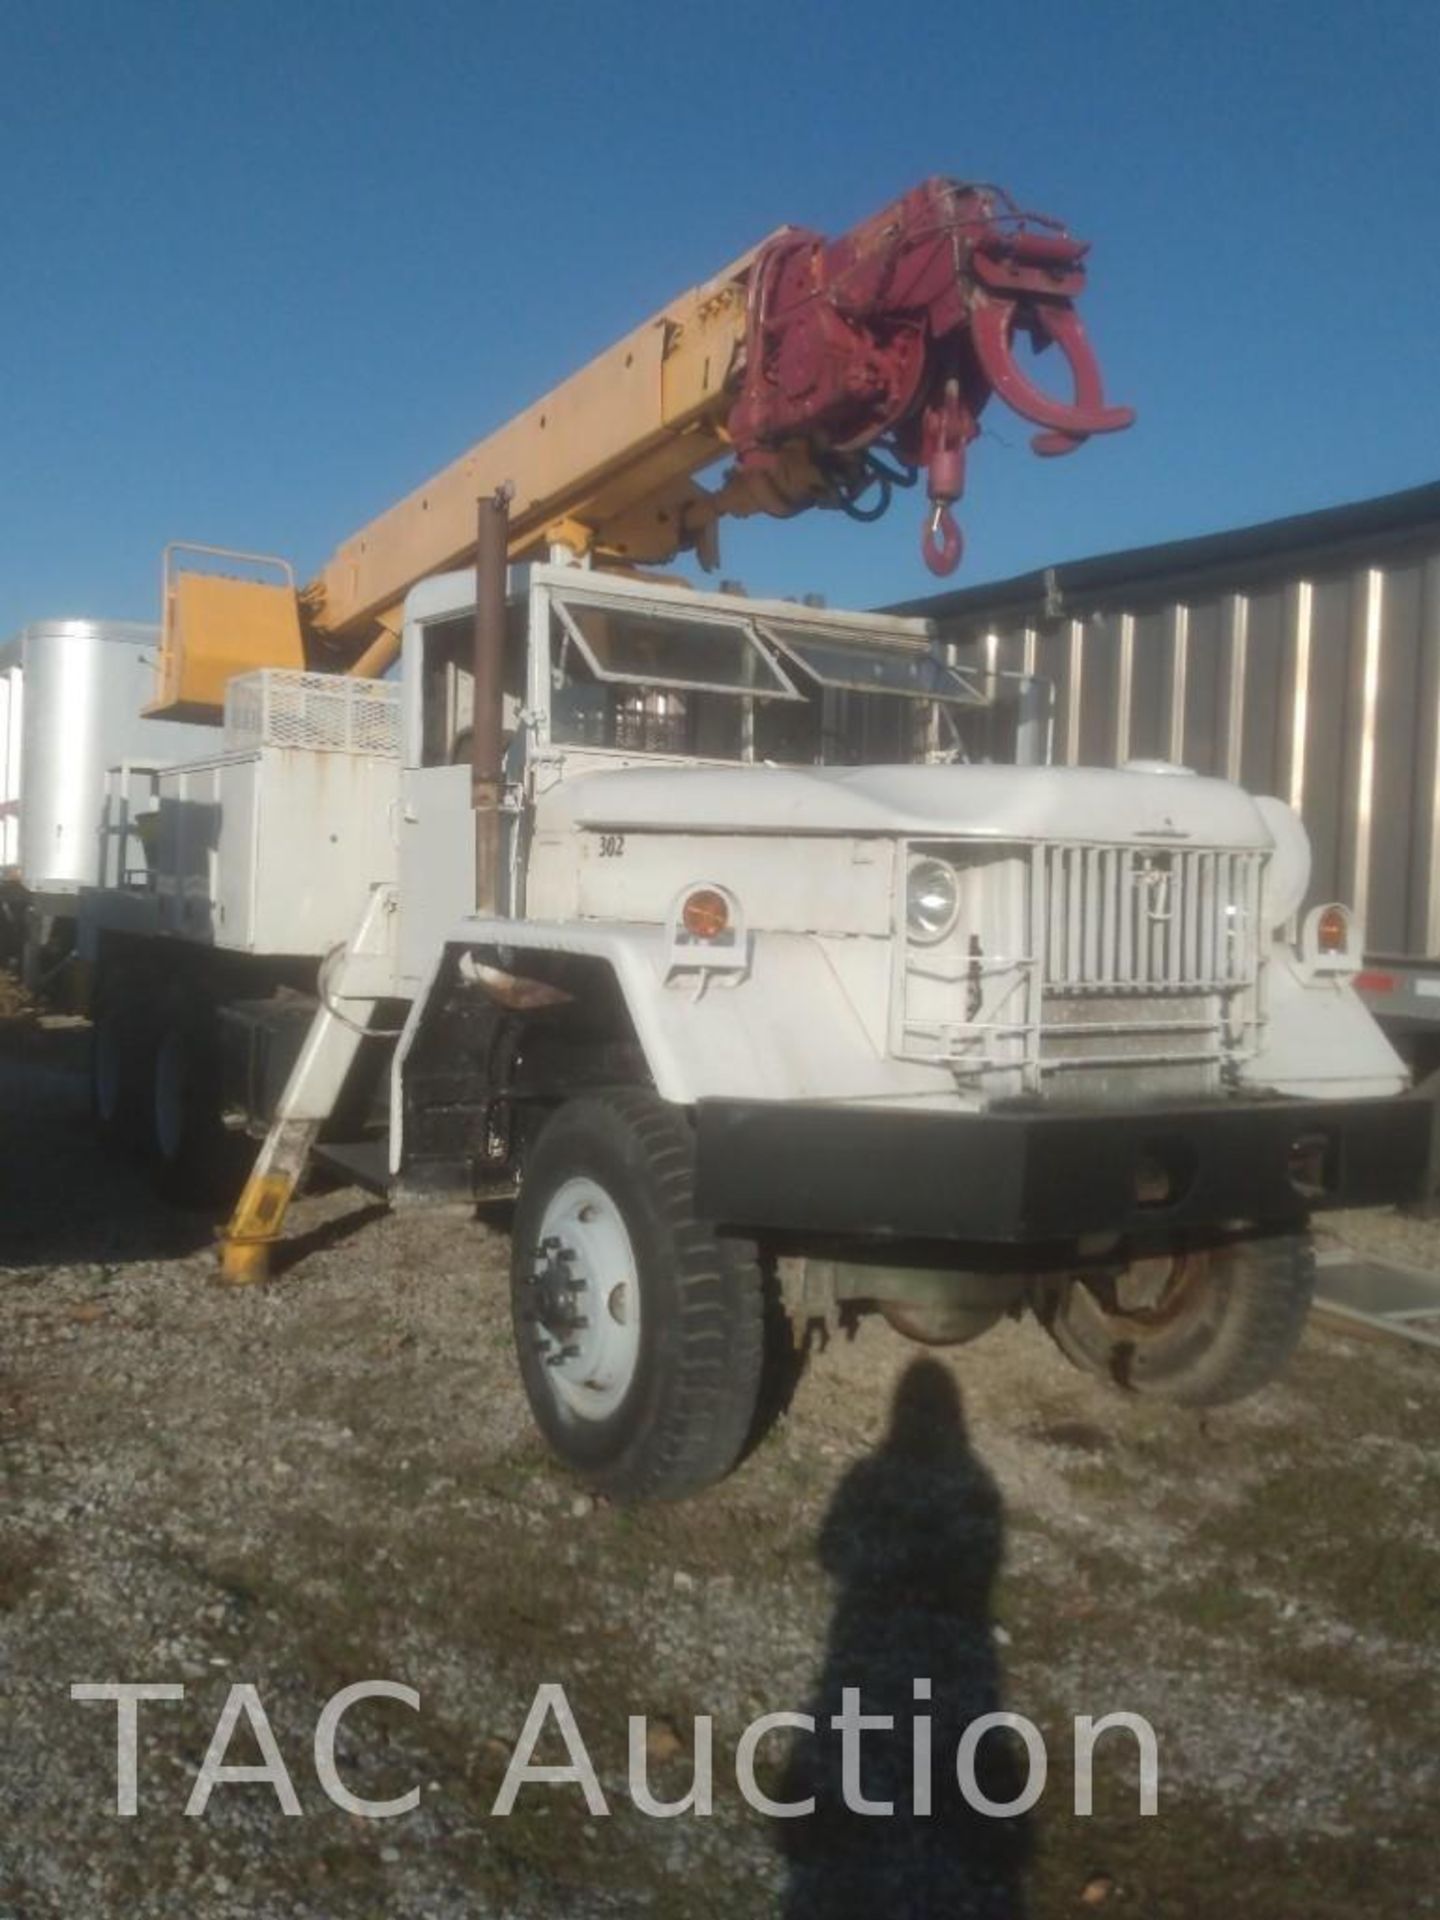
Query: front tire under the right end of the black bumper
1048,1233,1315,1407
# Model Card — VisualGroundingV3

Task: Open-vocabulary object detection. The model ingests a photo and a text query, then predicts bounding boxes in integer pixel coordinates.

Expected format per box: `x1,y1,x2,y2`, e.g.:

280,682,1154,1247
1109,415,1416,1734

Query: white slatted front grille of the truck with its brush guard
891,841,1267,1102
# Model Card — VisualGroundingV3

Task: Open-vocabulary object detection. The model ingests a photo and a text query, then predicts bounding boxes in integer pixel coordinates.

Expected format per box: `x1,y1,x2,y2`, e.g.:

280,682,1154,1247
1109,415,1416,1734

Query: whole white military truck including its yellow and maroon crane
64,179,1428,1498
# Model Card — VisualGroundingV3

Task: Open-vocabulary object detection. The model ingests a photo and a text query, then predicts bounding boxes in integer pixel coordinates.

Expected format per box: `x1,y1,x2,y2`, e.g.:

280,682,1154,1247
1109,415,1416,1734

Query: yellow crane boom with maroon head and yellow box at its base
150,180,1131,718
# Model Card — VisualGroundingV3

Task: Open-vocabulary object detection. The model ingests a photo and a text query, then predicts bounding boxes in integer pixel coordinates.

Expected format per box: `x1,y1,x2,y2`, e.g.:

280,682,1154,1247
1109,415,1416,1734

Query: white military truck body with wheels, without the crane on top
83,564,1428,1498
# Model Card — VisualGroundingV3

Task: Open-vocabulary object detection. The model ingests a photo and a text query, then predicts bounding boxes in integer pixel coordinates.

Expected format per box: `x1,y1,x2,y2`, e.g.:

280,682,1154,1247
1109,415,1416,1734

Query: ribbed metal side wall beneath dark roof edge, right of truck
937,532,1440,956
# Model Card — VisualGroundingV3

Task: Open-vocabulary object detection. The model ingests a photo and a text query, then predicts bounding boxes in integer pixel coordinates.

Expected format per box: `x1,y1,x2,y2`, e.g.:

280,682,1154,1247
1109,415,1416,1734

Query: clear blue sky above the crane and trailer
0,0,1440,632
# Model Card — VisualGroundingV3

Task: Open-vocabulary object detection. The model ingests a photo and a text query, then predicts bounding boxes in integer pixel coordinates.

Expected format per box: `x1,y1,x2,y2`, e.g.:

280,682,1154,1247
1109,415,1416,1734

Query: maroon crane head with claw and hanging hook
726,179,1135,574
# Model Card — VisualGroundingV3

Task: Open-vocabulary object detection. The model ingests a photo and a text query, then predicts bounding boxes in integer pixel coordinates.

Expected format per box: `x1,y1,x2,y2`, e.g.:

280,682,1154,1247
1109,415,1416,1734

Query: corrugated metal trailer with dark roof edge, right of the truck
899,484,1440,1077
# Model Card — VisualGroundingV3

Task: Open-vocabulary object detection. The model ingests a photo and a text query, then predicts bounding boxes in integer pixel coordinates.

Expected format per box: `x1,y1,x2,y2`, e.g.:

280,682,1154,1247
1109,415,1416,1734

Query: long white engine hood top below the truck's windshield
545,762,1271,849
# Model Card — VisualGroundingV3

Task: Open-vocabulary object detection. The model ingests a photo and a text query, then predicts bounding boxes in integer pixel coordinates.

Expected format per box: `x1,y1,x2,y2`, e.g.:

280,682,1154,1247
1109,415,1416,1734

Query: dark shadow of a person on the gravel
776,1359,1031,1920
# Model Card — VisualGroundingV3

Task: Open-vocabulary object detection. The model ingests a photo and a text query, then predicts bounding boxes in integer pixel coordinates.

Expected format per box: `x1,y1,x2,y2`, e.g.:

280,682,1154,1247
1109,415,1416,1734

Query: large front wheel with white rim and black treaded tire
511,1089,764,1501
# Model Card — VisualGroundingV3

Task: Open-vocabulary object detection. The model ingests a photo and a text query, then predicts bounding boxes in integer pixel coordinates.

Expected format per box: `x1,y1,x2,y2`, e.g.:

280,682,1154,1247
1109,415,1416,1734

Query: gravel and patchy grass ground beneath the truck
0,1031,1440,1920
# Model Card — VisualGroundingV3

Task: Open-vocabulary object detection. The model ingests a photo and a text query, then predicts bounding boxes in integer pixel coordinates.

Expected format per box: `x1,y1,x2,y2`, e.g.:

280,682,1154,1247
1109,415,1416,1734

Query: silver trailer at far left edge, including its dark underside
0,620,213,987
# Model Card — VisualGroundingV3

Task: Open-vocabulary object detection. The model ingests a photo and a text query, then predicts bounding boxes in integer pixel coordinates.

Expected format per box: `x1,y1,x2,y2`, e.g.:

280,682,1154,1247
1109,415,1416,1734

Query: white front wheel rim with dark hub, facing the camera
528,1179,639,1421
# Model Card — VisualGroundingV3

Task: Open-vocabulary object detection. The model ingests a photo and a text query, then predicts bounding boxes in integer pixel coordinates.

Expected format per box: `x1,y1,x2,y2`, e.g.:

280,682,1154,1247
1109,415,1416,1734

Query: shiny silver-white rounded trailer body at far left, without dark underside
0,620,219,895
